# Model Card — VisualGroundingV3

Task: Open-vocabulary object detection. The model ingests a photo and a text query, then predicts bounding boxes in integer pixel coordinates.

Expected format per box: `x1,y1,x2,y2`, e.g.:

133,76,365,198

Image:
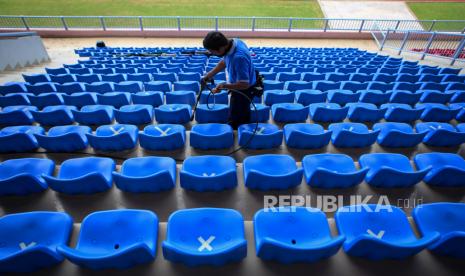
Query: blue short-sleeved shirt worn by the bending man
223,38,257,86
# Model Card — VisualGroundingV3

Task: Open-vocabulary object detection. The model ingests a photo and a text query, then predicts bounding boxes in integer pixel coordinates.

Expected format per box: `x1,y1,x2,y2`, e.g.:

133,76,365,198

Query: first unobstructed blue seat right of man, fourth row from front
271,103,308,122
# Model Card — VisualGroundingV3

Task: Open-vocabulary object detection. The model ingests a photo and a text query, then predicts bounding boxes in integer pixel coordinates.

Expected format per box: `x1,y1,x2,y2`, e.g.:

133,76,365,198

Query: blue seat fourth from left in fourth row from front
114,104,154,125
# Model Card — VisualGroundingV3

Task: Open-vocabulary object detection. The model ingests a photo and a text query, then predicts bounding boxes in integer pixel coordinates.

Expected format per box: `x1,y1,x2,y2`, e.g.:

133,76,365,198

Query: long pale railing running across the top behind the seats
0,15,465,33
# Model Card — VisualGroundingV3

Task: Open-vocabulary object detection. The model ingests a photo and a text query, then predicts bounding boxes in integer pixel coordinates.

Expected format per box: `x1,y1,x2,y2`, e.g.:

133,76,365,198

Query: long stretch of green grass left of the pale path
0,0,323,18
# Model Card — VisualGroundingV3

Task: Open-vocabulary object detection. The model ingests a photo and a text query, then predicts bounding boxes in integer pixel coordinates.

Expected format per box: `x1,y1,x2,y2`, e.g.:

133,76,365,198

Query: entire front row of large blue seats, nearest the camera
0,203,465,272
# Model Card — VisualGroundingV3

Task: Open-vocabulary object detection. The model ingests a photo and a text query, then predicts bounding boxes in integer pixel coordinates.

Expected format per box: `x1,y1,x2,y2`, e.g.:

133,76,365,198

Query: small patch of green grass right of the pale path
408,2,465,30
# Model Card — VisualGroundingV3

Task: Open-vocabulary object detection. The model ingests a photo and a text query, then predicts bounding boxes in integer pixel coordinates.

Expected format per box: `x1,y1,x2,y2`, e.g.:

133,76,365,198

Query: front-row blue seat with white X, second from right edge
335,204,439,260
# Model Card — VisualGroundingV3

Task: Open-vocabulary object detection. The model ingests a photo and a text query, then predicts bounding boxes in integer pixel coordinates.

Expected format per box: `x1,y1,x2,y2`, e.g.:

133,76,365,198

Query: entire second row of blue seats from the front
0,152,465,195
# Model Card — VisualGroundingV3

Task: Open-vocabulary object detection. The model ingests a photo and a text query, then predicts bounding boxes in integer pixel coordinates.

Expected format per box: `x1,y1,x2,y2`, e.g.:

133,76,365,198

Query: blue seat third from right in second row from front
302,153,368,189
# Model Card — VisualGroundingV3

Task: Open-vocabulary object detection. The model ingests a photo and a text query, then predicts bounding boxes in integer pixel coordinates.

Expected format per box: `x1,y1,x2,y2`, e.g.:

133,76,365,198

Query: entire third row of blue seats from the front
0,122,465,152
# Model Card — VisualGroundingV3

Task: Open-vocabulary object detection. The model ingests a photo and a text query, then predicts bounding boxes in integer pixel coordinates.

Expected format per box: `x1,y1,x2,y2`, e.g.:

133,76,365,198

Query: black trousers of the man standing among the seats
228,87,253,129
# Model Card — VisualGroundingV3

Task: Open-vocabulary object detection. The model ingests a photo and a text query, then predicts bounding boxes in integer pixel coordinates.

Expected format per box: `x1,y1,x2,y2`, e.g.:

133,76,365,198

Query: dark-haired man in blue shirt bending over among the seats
203,32,257,129
